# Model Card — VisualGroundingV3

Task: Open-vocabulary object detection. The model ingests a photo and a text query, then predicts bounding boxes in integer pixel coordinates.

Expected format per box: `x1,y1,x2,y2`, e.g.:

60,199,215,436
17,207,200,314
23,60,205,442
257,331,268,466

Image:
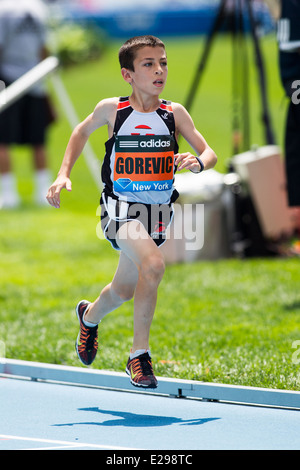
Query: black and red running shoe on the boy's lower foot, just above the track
126,352,157,388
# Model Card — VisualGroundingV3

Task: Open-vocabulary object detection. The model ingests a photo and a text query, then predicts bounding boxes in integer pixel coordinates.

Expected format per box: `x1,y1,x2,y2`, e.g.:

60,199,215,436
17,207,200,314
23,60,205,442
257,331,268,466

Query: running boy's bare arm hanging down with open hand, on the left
46,98,117,208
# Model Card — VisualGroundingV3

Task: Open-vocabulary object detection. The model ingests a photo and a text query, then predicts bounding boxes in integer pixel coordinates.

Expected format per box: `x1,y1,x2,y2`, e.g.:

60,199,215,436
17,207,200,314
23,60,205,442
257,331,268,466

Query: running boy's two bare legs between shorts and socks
84,220,164,352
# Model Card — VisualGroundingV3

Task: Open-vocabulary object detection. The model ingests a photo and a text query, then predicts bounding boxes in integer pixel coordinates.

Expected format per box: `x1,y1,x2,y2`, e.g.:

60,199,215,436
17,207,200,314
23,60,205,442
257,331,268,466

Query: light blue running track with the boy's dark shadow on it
0,360,300,452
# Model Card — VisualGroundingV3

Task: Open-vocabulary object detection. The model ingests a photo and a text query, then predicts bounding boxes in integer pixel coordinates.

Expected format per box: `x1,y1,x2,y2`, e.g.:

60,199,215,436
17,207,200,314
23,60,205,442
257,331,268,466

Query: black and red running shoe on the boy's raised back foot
75,300,98,366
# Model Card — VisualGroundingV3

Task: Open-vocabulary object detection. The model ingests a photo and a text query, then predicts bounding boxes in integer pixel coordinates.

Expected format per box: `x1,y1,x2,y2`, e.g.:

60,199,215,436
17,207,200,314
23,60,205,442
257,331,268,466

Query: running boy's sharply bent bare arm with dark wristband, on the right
173,103,217,173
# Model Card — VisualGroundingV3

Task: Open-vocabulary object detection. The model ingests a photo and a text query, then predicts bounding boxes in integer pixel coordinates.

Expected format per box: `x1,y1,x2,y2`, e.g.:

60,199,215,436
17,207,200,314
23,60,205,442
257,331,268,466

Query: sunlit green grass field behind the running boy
0,37,300,390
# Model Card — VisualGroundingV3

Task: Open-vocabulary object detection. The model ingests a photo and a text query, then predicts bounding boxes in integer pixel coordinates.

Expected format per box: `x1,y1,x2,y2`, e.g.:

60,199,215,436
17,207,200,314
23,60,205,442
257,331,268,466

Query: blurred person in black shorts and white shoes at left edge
0,0,53,208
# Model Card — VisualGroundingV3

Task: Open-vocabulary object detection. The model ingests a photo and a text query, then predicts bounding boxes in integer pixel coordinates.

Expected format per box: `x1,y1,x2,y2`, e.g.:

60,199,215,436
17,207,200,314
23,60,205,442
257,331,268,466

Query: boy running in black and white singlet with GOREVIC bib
47,36,217,388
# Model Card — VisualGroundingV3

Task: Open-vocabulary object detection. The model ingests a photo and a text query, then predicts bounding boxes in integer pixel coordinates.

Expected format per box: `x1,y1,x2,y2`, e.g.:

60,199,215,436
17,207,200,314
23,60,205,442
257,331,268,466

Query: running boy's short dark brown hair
119,35,165,72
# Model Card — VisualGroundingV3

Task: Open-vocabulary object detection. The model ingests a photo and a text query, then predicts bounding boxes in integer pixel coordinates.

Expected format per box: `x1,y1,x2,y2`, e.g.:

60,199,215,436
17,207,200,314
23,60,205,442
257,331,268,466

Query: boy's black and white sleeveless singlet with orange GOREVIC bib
101,97,178,204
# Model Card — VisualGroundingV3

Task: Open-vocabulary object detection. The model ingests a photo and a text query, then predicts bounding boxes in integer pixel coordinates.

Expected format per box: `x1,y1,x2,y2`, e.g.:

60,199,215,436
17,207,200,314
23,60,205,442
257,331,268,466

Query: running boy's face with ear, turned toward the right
122,46,168,96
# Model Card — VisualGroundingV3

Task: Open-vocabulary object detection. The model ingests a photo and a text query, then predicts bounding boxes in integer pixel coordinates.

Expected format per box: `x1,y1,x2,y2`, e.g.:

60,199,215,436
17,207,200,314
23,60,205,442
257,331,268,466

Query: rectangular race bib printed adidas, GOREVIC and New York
114,135,175,192
